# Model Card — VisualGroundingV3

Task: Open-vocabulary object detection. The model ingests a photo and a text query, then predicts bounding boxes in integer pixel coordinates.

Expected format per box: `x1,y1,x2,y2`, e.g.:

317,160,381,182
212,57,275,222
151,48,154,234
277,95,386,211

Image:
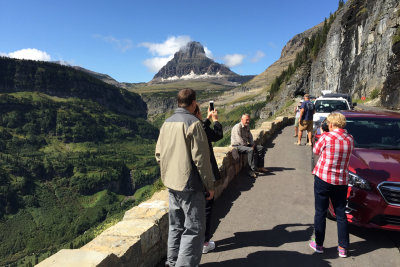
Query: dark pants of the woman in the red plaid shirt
314,176,349,249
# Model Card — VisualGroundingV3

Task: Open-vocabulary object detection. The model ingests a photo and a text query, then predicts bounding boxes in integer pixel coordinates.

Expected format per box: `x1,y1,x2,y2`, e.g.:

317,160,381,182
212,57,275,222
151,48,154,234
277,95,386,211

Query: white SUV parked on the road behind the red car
313,97,351,130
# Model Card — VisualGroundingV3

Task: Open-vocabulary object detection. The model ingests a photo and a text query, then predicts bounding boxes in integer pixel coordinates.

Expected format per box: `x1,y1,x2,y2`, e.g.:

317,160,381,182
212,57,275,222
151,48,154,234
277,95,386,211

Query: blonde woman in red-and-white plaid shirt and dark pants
309,113,354,257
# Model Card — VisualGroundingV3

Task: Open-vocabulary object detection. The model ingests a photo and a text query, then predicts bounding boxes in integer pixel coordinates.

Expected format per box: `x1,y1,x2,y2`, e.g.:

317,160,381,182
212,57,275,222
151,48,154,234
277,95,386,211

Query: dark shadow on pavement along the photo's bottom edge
201,251,331,267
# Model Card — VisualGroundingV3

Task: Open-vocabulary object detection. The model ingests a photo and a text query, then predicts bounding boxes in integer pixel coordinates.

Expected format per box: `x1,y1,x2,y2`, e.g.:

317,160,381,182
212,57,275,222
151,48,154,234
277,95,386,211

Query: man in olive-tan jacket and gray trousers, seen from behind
155,89,215,266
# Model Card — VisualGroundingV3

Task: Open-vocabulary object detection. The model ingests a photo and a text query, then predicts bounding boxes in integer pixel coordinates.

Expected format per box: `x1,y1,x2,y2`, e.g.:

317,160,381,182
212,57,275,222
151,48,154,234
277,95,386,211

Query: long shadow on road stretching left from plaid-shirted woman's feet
215,223,313,252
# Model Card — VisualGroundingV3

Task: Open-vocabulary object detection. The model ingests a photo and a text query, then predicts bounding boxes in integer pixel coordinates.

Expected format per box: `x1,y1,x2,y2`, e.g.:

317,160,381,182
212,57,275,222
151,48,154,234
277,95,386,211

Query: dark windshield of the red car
346,118,400,150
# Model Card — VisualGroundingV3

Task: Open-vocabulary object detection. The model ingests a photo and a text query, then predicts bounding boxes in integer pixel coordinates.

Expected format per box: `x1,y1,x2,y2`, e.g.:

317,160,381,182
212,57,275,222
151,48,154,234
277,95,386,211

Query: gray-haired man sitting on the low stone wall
231,114,268,178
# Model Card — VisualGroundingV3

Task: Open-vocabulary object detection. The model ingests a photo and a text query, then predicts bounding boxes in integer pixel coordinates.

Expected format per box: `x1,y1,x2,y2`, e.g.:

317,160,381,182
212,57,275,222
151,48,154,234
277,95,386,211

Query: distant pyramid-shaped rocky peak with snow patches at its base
151,42,239,83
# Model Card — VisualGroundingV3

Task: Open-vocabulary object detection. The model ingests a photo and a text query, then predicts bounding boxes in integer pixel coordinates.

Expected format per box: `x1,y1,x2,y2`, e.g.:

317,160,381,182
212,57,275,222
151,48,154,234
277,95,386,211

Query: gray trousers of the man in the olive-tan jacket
166,189,205,267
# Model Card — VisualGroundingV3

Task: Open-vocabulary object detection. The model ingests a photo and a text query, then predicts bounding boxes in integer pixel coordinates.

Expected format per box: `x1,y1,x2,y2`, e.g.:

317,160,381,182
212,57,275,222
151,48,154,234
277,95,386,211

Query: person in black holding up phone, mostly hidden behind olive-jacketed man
194,105,224,254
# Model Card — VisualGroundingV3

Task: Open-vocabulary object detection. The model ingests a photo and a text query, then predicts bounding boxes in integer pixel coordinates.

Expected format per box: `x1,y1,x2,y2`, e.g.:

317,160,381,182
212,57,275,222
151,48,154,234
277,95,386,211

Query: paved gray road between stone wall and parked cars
201,127,400,267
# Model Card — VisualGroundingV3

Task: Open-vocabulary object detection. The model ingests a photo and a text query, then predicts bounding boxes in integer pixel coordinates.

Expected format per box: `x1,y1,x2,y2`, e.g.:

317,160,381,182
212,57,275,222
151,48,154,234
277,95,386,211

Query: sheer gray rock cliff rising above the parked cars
310,0,400,108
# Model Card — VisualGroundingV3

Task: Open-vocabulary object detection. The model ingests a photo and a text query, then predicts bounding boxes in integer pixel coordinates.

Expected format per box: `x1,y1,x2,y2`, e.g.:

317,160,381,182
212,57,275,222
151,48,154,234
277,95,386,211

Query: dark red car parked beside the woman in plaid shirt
312,111,400,231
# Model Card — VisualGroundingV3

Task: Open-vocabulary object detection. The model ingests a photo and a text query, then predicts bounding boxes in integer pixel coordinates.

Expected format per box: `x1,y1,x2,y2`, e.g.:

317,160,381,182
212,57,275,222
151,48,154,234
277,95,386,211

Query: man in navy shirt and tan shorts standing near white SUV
295,94,315,146
